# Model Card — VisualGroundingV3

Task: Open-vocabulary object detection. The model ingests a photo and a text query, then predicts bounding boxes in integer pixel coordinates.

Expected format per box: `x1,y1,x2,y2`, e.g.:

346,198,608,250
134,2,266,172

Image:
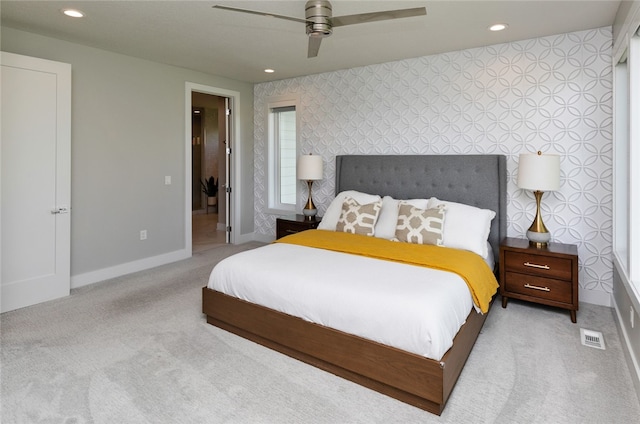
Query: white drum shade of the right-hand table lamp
517,152,560,191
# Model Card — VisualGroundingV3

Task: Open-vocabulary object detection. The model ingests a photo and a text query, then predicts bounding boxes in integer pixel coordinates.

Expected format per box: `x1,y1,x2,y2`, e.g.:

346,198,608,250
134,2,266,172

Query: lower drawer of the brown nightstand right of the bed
505,272,572,304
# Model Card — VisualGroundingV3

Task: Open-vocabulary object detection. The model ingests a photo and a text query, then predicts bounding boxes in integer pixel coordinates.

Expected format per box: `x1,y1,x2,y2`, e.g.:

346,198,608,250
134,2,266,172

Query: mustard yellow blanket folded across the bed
276,230,498,313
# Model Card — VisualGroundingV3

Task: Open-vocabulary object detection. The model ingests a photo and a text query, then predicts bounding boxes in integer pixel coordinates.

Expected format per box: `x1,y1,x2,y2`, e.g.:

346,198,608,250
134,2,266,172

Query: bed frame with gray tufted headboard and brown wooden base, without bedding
202,155,506,415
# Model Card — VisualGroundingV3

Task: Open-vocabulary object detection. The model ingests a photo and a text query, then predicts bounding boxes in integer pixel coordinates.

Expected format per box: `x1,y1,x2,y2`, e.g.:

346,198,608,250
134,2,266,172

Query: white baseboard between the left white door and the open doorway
71,249,191,289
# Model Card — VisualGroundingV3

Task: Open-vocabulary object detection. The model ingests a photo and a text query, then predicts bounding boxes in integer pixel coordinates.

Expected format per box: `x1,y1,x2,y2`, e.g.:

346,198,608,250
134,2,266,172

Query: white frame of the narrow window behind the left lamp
265,96,300,215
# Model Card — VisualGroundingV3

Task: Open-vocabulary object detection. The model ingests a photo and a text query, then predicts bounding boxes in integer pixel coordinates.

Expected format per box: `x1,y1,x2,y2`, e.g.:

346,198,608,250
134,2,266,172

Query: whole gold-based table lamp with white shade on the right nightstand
517,152,560,248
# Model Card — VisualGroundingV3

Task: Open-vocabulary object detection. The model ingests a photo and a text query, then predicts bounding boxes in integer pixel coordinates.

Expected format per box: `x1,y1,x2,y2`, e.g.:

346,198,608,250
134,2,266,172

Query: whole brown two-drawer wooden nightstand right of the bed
500,237,578,323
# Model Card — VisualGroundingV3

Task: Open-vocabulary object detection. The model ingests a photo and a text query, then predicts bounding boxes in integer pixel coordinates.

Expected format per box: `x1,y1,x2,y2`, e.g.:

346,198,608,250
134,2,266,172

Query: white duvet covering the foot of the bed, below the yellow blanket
208,243,473,360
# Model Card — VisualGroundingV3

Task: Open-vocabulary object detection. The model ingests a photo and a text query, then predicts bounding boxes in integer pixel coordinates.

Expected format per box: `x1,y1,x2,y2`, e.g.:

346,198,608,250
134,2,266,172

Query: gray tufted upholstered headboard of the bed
335,155,507,262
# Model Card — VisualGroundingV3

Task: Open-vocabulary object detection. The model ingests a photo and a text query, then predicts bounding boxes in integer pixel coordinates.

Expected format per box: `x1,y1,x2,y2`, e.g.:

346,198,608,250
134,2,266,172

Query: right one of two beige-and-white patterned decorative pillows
396,202,445,246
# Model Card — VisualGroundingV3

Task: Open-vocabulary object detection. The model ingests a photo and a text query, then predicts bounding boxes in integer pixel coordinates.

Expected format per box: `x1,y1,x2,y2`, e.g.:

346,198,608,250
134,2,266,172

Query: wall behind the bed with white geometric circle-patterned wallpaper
254,27,613,306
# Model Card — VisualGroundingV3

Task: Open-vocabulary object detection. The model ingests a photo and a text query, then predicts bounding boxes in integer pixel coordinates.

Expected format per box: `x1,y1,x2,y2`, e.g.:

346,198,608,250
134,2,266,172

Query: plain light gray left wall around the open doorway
1,26,253,284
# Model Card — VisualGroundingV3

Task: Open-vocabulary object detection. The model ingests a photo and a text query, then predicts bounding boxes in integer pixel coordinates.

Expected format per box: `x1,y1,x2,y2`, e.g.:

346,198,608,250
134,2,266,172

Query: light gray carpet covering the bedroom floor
0,243,640,423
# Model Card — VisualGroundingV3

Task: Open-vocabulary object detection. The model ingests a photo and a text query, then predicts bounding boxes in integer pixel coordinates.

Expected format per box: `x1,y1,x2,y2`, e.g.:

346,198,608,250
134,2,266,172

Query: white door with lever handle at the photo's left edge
0,52,71,312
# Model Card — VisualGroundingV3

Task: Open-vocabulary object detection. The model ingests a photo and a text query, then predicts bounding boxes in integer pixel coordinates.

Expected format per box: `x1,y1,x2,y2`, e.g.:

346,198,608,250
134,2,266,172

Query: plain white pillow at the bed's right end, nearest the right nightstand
429,197,496,258
